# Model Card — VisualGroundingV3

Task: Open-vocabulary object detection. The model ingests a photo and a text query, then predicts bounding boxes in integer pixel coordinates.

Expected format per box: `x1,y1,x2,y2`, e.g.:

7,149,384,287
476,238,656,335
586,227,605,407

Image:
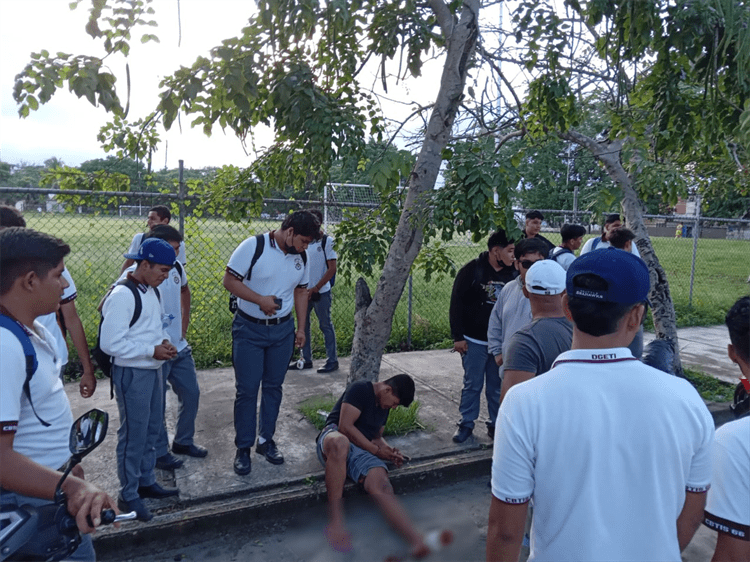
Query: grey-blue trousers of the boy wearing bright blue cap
112,365,164,501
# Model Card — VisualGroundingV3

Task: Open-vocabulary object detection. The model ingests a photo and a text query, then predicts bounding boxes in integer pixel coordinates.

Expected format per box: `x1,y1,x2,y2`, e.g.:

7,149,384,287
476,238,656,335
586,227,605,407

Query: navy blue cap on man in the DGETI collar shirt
566,248,651,305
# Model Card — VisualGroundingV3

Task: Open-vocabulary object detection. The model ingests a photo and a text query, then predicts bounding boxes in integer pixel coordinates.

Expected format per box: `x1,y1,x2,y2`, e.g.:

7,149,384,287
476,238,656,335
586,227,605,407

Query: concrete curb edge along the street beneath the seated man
94,446,492,559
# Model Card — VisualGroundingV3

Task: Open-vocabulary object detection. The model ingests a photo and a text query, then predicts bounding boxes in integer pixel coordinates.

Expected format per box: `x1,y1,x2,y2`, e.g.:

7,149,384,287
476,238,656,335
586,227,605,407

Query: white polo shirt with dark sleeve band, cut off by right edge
703,417,750,541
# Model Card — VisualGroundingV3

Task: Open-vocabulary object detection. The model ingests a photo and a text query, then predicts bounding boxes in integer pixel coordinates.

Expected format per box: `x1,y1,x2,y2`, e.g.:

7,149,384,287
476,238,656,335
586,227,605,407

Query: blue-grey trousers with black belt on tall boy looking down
232,314,294,449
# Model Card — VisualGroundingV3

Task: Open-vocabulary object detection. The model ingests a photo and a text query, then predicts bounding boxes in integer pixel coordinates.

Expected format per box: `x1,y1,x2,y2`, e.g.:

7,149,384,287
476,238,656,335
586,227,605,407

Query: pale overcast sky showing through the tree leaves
0,0,512,169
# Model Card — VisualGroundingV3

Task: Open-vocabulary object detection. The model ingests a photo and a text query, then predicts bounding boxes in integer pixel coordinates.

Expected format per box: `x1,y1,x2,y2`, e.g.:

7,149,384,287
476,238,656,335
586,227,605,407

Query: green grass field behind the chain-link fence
19,213,750,368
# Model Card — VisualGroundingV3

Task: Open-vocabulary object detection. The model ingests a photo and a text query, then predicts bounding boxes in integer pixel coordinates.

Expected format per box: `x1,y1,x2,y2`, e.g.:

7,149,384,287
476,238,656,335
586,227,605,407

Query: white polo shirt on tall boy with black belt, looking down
227,232,309,320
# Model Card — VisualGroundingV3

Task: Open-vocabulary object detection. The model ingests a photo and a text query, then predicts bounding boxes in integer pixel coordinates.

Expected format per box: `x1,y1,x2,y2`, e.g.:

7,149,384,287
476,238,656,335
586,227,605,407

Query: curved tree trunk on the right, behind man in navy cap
560,130,684,377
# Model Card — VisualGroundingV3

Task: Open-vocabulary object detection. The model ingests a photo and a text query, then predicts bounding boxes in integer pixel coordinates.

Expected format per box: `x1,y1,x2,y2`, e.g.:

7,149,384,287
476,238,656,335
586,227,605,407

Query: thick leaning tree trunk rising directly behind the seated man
349,0,480,382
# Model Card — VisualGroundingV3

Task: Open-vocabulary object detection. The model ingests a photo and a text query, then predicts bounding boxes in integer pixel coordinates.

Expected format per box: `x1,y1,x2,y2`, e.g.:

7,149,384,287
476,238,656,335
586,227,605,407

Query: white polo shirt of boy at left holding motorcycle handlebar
0,321,73,470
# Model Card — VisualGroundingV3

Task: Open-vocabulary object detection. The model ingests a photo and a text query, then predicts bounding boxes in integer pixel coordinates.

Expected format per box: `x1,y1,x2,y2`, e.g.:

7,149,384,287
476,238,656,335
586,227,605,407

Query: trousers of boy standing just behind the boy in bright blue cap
156,346,201,459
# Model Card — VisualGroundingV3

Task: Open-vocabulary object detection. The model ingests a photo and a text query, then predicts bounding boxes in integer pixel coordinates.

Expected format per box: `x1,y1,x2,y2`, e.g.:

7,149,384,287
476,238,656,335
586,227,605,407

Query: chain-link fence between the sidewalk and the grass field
0,185,750,376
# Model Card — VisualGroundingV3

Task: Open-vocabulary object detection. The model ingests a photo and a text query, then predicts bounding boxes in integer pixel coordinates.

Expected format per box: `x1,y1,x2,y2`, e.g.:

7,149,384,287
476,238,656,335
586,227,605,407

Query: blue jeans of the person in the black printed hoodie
458,340,500,429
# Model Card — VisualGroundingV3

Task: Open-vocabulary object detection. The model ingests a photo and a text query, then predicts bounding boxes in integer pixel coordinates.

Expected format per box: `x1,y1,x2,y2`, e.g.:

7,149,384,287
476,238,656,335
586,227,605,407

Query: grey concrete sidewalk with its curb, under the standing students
66,327,748,558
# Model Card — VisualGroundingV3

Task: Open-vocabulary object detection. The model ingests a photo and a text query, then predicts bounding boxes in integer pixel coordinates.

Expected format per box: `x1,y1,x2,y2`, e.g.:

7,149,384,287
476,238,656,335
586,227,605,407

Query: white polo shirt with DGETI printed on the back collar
492,348,714,562
